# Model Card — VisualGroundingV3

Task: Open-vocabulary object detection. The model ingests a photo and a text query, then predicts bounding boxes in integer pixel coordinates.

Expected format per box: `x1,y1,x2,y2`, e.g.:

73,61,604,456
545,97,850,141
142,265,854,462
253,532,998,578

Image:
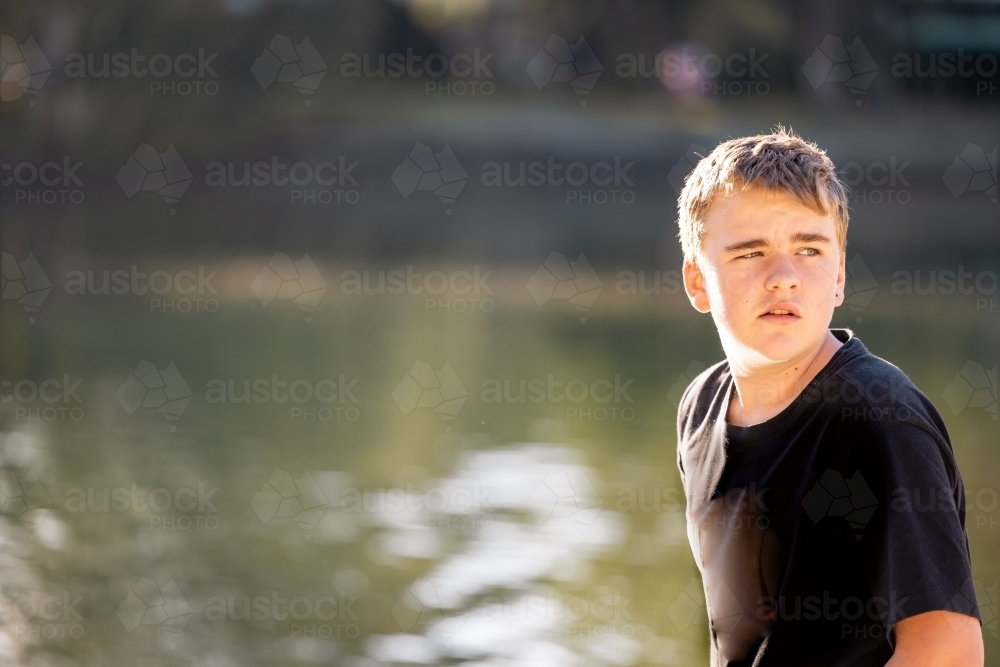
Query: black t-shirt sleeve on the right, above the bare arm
855,422,982,630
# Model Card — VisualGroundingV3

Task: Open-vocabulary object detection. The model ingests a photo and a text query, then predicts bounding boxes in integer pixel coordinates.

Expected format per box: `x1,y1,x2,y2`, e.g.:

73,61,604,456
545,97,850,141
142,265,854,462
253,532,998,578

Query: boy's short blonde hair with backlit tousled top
677,125,850,262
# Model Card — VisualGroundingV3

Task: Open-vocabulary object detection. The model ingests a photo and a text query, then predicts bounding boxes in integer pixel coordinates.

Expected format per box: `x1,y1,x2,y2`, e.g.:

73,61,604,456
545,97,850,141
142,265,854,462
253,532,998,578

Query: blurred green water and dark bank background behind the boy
0,0,1000,667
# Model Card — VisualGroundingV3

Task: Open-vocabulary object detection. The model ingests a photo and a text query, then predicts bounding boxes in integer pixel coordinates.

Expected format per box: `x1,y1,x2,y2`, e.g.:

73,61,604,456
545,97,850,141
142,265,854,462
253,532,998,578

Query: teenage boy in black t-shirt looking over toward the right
677,126,983,667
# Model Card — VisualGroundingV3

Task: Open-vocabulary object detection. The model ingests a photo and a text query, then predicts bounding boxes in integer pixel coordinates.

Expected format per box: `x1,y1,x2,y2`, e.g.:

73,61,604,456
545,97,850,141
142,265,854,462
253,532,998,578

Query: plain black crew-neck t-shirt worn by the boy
677,329,982,667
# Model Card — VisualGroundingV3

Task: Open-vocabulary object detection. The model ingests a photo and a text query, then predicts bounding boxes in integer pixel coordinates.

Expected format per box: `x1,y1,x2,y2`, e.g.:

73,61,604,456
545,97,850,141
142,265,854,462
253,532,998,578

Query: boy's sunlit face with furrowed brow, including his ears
684,189,845,367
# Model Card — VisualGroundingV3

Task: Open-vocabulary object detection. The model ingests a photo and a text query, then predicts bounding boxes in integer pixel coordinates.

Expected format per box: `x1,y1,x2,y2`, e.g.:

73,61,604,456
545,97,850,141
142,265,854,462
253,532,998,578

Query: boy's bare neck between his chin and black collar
726,330,844,426
